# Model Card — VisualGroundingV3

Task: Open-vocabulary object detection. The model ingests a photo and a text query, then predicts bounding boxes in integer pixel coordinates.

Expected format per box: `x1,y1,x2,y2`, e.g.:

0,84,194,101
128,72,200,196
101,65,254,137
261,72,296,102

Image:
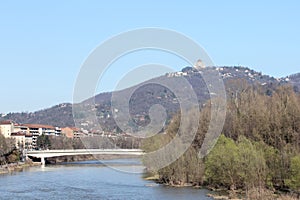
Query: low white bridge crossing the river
25,149,144,166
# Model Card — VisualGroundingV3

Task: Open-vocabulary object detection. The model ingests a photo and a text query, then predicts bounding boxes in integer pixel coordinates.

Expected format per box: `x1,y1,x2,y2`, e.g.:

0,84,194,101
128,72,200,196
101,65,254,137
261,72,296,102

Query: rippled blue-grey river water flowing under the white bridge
0,159,211,200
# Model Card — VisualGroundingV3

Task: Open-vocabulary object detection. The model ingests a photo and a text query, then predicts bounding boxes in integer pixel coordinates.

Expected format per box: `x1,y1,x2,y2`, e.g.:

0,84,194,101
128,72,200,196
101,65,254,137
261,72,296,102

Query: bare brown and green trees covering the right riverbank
142,81,300,199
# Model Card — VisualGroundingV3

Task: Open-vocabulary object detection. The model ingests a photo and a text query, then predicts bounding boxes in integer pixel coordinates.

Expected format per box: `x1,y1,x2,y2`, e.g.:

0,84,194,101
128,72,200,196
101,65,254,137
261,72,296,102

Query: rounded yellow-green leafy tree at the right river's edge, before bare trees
205,135,267,191
